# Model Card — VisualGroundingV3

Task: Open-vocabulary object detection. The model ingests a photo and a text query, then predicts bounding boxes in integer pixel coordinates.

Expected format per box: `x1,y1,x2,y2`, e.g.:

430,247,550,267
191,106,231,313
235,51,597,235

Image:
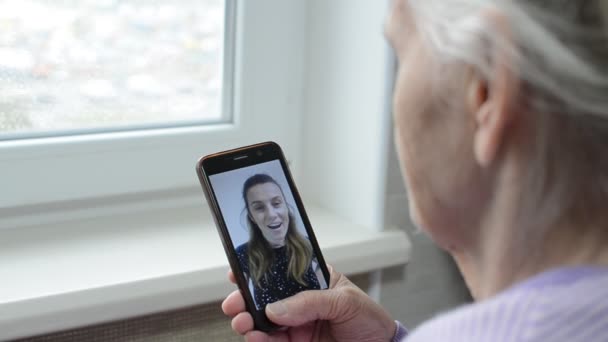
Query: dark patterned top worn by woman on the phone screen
236,243,321,310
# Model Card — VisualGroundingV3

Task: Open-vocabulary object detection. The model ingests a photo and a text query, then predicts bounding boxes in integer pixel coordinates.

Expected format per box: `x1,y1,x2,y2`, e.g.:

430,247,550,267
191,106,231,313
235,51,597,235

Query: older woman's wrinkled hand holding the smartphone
222,268,396,342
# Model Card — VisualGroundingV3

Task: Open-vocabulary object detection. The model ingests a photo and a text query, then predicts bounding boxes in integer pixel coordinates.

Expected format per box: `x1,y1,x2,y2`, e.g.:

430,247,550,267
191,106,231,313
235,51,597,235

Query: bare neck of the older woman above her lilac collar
452,162,608,300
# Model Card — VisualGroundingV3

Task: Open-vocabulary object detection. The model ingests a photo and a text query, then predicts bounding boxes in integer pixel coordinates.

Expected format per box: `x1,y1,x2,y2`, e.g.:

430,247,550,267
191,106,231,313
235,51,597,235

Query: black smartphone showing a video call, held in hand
196,142,329,331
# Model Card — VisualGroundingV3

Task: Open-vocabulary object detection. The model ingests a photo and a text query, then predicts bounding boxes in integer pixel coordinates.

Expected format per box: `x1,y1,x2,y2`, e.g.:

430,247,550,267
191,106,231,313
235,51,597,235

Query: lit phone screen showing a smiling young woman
208,159,328,310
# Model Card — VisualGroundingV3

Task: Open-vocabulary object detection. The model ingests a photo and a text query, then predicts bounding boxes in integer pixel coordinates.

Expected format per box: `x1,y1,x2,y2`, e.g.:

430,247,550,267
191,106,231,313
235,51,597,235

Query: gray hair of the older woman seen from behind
405,0,608,230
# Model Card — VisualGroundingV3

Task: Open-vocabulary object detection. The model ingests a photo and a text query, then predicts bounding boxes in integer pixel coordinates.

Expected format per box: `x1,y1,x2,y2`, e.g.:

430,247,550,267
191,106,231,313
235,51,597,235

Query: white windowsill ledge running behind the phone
0,204,410,340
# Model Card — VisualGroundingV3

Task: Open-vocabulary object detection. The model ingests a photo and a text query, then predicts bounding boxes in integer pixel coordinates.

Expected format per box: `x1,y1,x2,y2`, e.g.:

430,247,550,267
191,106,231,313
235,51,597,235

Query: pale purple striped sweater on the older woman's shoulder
401,266,608,342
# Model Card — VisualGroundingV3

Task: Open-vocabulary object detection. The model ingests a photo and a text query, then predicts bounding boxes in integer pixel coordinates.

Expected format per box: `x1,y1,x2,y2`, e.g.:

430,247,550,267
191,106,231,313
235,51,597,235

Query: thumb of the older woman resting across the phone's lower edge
266,290,349,327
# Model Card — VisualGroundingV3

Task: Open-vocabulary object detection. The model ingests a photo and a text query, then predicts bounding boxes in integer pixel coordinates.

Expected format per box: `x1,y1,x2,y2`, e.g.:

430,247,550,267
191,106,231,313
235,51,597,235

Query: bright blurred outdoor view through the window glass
0,0,225,139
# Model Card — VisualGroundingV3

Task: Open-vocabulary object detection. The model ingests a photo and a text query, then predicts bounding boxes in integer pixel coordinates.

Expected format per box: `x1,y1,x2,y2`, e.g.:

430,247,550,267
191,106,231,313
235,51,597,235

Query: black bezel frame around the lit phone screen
196,141,330,331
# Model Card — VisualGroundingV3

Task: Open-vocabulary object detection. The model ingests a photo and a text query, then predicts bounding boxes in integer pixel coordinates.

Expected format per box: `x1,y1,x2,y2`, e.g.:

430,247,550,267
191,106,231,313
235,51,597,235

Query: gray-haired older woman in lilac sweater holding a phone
223,0,608,342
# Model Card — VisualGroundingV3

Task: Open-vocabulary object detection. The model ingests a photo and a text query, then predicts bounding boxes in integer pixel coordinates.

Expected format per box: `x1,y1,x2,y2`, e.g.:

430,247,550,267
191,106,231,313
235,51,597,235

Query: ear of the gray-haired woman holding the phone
466,11,520,167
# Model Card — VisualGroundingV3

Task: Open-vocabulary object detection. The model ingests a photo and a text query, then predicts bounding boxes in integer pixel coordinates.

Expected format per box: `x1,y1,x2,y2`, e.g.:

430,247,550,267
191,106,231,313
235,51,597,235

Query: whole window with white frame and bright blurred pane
0,0,306,208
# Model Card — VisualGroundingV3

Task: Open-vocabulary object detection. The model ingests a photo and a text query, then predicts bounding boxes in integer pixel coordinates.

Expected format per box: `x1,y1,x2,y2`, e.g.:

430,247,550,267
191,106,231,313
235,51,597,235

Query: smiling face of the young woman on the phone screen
246,183,289,248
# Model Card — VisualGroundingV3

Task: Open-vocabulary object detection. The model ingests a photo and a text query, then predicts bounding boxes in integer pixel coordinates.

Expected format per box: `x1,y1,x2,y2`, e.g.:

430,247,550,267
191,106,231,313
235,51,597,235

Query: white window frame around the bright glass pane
0,0,306,214
